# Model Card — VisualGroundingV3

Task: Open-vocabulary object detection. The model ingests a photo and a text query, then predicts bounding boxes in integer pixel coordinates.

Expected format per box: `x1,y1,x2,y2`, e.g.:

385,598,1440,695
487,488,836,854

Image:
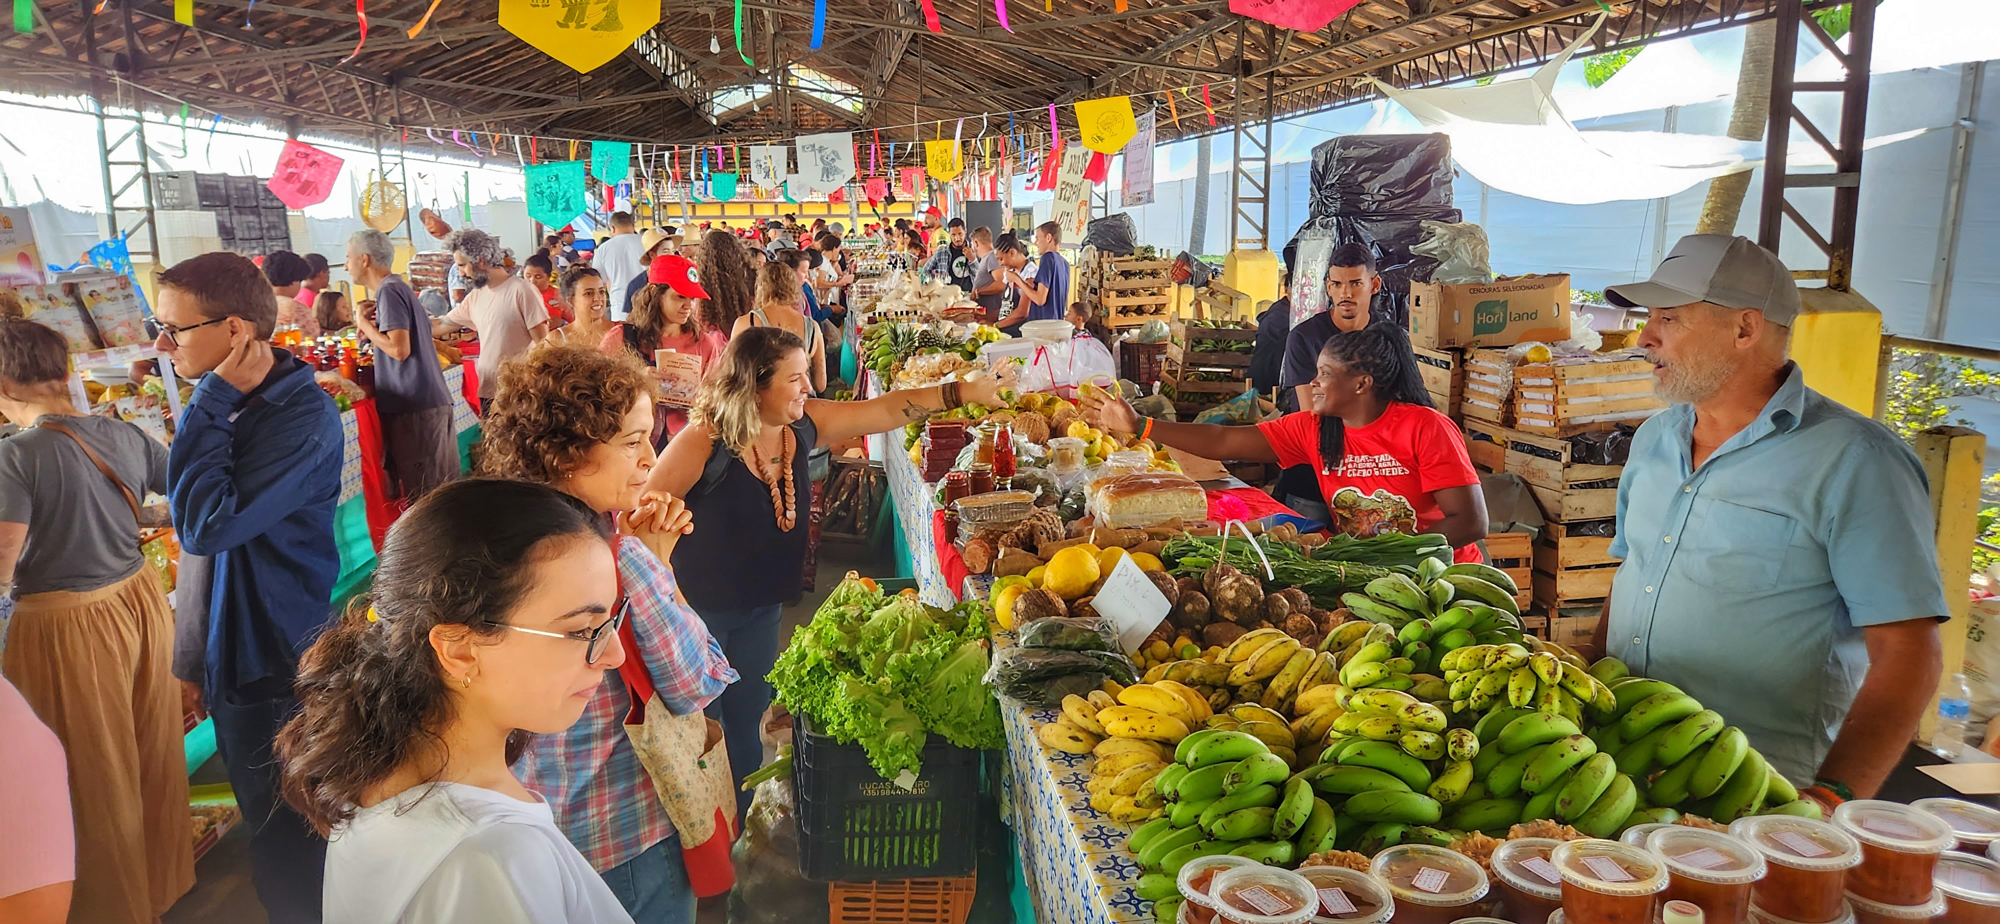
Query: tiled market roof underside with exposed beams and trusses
0,0,1784,160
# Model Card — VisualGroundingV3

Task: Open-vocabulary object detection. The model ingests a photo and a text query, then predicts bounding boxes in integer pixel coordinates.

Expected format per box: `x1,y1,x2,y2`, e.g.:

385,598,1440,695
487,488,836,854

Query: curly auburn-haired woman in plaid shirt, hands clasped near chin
480,342,732,924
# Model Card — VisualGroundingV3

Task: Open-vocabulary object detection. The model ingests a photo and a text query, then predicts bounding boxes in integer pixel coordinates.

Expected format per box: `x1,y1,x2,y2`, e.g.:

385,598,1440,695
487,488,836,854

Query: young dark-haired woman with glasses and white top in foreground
278,480,682,924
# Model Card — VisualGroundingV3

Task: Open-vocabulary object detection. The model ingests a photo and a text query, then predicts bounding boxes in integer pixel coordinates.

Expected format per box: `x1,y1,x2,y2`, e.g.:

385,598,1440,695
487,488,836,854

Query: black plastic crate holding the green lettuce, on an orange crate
792,716,980,882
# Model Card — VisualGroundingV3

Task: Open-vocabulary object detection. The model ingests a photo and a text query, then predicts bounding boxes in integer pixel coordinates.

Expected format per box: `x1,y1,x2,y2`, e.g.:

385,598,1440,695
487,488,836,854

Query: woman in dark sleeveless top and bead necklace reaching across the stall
652,328,1000,808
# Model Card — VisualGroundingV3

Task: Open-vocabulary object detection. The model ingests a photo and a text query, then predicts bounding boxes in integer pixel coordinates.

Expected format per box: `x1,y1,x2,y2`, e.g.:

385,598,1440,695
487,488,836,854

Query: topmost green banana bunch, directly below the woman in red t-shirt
1340,558,1522,674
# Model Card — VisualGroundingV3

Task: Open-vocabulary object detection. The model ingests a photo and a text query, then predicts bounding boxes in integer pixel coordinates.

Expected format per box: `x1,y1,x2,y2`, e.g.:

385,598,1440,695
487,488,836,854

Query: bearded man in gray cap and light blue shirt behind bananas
1596,234,1946,802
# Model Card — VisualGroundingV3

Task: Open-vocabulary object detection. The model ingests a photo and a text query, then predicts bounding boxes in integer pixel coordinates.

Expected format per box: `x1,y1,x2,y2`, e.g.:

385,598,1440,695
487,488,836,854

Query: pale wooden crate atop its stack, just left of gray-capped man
1512,354,1666,436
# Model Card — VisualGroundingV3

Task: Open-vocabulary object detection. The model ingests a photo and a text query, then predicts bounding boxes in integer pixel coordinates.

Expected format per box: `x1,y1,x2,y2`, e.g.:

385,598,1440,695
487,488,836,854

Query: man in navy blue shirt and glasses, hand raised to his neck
154,252,342,922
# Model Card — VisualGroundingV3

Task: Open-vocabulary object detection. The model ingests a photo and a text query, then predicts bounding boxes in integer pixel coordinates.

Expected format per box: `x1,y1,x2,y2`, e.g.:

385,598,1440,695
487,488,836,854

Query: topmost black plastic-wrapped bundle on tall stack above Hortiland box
1310,134,1452,218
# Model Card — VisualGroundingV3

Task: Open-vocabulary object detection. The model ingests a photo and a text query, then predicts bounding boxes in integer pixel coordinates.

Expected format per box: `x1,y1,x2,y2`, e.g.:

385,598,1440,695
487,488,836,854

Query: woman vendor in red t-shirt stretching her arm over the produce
1086,324,1486,562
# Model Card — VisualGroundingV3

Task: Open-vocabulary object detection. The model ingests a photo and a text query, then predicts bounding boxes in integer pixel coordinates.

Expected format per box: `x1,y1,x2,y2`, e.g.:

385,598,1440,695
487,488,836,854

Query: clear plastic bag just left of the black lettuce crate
728,774,828,924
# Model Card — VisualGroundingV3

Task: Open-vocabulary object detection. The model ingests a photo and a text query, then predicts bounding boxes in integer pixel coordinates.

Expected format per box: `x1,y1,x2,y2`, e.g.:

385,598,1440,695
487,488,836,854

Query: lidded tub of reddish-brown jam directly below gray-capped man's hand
1730,814,1862,924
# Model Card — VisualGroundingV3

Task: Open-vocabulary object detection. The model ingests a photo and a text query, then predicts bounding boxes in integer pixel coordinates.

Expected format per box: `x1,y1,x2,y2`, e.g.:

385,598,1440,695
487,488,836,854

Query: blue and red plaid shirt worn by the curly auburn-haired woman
514,536,738,872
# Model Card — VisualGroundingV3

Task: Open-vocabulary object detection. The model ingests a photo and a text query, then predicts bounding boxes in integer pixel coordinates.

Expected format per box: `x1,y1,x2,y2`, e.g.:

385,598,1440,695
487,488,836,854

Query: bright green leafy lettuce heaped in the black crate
770,576,1006,780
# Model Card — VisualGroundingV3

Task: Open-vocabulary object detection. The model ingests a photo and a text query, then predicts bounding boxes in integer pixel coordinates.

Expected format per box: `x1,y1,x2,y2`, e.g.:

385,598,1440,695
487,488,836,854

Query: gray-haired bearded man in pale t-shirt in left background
430,228,548,404
